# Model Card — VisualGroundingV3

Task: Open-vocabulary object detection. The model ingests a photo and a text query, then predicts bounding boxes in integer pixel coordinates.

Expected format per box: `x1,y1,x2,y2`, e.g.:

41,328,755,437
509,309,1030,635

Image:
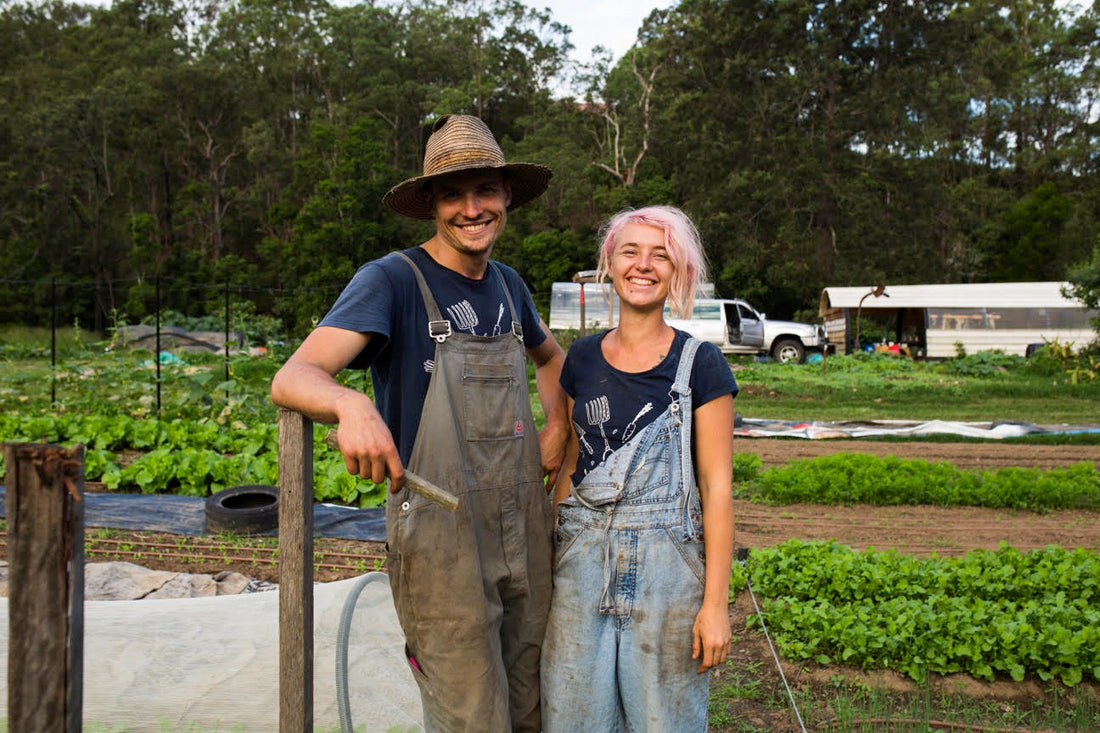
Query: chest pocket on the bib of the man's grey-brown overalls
462,362,526,440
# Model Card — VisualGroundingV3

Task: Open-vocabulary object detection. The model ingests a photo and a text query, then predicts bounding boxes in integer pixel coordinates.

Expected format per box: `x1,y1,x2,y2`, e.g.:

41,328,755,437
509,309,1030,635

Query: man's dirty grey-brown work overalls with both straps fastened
386,255,552,733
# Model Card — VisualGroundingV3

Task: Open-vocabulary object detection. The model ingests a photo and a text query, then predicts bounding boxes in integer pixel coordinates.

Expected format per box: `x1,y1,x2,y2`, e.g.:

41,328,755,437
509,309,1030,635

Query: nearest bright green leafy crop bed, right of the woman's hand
748,540,1100,686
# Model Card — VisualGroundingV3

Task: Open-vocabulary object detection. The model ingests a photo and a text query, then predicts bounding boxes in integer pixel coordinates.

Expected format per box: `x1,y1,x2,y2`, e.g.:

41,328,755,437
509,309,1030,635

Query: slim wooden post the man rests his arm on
278,409,314,733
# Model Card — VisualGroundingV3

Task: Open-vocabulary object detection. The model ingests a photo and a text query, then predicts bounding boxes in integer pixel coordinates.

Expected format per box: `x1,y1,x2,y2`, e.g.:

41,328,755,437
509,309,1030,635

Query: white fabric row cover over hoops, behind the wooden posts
0,572,422,733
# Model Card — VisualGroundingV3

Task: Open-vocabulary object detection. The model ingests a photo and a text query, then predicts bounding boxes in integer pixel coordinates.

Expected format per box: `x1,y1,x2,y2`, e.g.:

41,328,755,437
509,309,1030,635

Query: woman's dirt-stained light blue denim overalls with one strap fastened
542,339,708,733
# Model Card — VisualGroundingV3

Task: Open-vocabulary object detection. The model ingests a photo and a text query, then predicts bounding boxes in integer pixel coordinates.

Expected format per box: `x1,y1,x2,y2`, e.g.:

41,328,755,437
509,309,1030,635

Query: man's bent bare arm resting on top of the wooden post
271,326,405,491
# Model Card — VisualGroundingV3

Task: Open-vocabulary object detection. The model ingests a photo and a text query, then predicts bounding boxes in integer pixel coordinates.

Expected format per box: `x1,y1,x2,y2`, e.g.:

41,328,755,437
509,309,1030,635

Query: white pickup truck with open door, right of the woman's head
664,298,828,363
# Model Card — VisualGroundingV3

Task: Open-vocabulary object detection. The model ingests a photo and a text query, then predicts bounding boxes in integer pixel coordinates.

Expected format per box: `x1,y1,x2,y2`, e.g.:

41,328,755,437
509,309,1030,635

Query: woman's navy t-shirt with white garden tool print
561,329,738,486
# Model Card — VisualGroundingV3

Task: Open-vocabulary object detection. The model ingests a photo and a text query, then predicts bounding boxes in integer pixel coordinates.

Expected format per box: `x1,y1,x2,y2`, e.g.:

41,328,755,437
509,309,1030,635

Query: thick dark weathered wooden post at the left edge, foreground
3,444,84,733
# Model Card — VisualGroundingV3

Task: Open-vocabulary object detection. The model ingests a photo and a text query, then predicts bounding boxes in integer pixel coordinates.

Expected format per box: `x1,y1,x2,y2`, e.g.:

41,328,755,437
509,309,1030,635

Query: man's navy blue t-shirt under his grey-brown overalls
320,247,546,463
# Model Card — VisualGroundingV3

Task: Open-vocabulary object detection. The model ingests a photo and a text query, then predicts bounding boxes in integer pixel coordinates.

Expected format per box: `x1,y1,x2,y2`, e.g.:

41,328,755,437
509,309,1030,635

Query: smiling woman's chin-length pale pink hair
596,206,706,318
